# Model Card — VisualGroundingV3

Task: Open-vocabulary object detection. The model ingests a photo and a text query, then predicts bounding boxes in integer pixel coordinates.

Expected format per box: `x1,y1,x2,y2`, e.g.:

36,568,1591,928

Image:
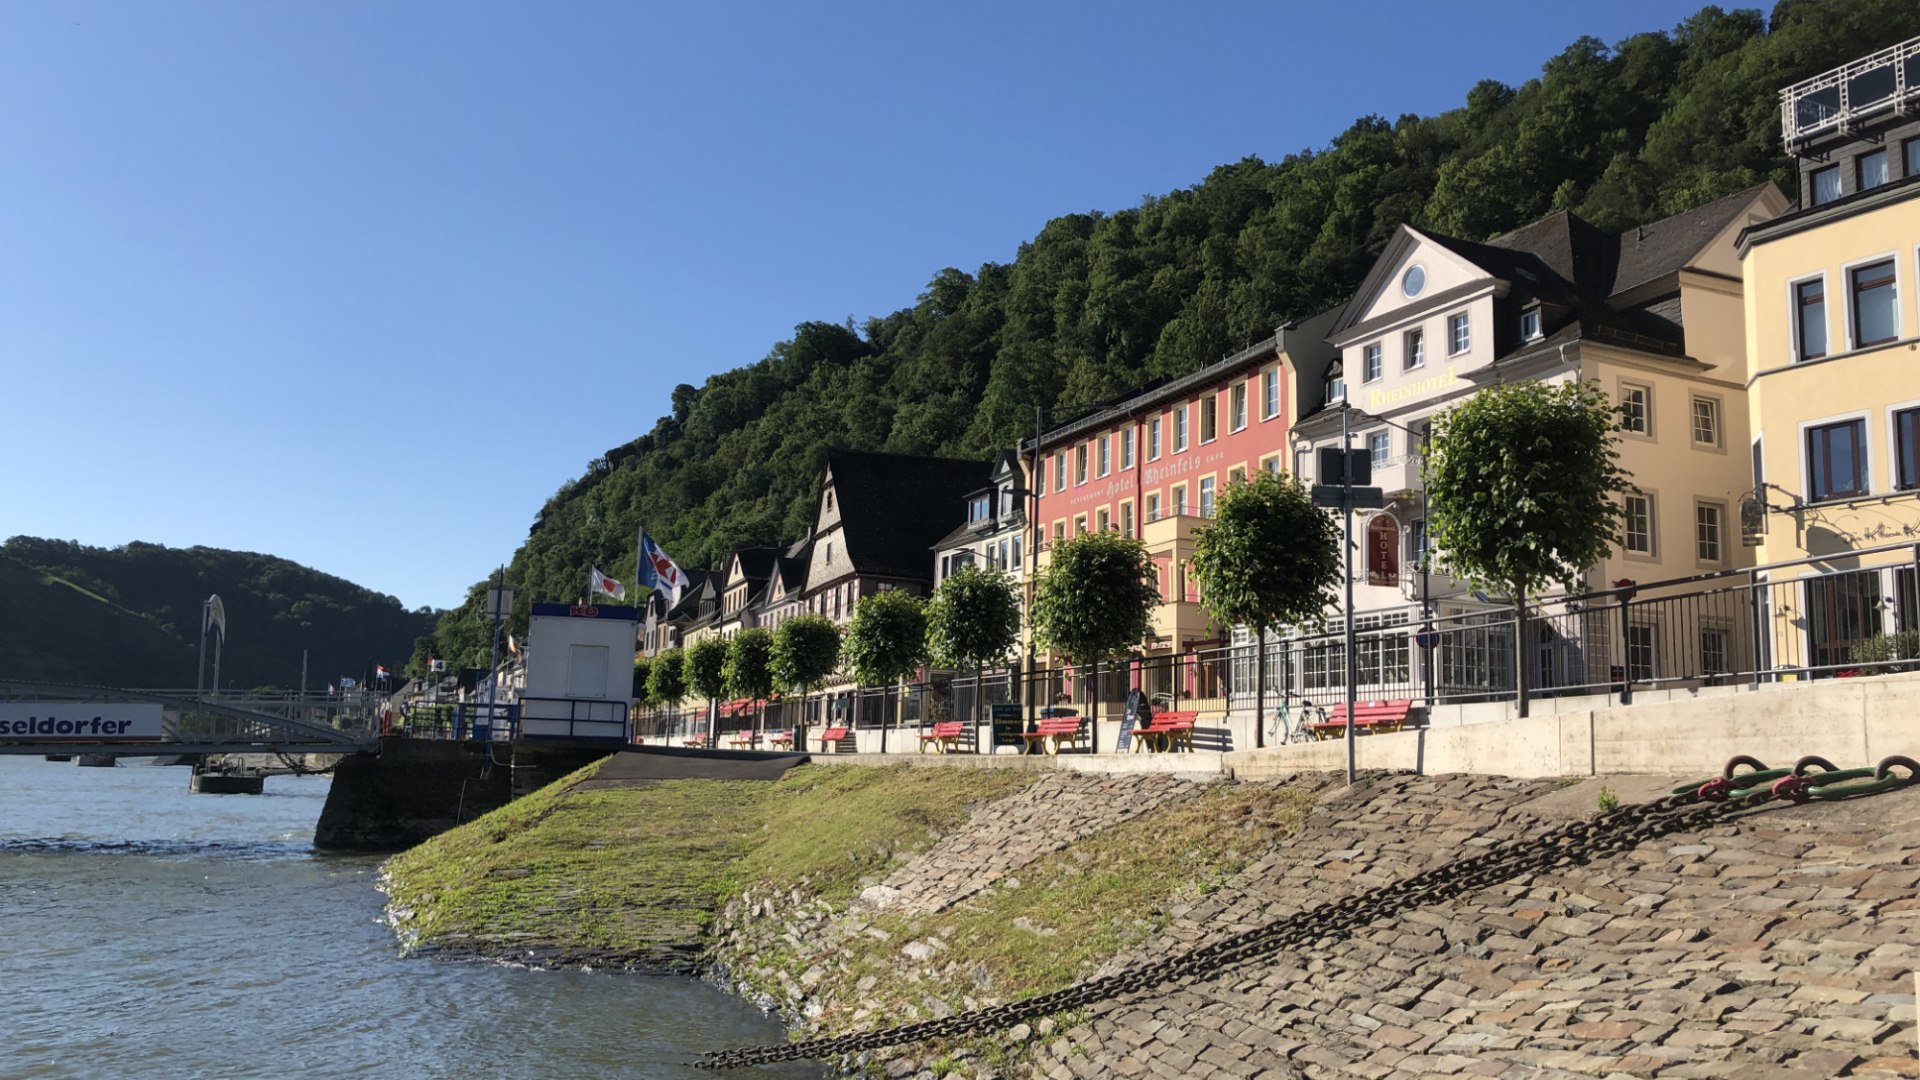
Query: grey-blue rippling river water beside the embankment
0,757,820,1078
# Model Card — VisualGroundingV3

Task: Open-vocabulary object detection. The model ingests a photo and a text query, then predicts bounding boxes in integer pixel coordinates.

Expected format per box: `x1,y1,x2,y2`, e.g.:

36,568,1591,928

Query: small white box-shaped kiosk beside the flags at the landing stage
520,603,639,742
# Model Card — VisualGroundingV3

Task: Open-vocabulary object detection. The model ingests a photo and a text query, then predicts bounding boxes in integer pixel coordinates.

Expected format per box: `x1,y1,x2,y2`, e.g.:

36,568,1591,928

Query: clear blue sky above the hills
0,0,1697,607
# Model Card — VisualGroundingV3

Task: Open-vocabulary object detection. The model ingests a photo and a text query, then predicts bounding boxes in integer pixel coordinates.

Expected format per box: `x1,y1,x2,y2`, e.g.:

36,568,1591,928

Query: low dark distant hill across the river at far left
0,536,438,690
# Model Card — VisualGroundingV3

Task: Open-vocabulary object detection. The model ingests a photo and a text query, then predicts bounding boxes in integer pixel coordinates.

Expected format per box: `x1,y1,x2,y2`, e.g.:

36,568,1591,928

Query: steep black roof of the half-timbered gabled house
828,450,991,580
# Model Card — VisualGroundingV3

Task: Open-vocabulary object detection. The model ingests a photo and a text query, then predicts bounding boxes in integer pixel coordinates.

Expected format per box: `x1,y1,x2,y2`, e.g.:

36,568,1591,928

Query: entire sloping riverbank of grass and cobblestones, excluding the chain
378,767,1920,1078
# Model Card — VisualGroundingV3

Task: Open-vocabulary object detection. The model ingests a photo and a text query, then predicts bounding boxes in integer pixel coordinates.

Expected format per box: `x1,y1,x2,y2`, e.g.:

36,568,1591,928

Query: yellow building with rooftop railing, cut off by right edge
1740,38,1920,675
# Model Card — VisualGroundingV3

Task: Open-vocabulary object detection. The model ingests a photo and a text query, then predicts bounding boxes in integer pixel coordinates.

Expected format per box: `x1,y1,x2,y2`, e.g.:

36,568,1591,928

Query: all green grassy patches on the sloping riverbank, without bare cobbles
388,753,1313,1067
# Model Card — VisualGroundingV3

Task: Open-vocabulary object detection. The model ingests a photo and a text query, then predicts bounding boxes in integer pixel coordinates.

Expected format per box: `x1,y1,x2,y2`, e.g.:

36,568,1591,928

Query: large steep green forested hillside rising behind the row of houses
419,0,1920,663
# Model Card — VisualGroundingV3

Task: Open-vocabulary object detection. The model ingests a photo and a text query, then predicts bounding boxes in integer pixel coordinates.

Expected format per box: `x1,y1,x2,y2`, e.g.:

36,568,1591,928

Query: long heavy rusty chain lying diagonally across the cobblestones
693,757,1920,1070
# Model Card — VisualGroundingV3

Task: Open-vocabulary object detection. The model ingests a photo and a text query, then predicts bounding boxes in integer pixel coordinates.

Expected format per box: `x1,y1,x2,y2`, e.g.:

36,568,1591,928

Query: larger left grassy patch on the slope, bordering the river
388,765,1039,965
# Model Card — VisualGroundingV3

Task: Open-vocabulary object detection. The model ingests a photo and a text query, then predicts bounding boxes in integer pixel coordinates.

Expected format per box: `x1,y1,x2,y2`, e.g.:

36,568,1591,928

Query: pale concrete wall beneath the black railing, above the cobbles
1225,675,1920,778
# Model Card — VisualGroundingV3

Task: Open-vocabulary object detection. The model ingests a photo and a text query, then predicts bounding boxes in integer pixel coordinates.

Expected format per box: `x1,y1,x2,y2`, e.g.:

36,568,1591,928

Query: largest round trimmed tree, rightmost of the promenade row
1423,382,1634,717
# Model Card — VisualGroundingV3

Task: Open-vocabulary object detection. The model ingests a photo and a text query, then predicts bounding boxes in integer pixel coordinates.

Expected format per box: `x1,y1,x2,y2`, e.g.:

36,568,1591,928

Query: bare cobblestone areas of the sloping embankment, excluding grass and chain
722,774,1920,1080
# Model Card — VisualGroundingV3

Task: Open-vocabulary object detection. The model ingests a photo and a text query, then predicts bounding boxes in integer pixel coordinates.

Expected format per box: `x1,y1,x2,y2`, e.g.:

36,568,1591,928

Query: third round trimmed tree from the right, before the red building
1033,532,1160,753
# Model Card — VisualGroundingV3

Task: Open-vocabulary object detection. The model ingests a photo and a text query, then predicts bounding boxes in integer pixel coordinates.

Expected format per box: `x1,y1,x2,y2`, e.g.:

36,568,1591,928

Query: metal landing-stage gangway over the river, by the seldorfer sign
0,678,384,757
